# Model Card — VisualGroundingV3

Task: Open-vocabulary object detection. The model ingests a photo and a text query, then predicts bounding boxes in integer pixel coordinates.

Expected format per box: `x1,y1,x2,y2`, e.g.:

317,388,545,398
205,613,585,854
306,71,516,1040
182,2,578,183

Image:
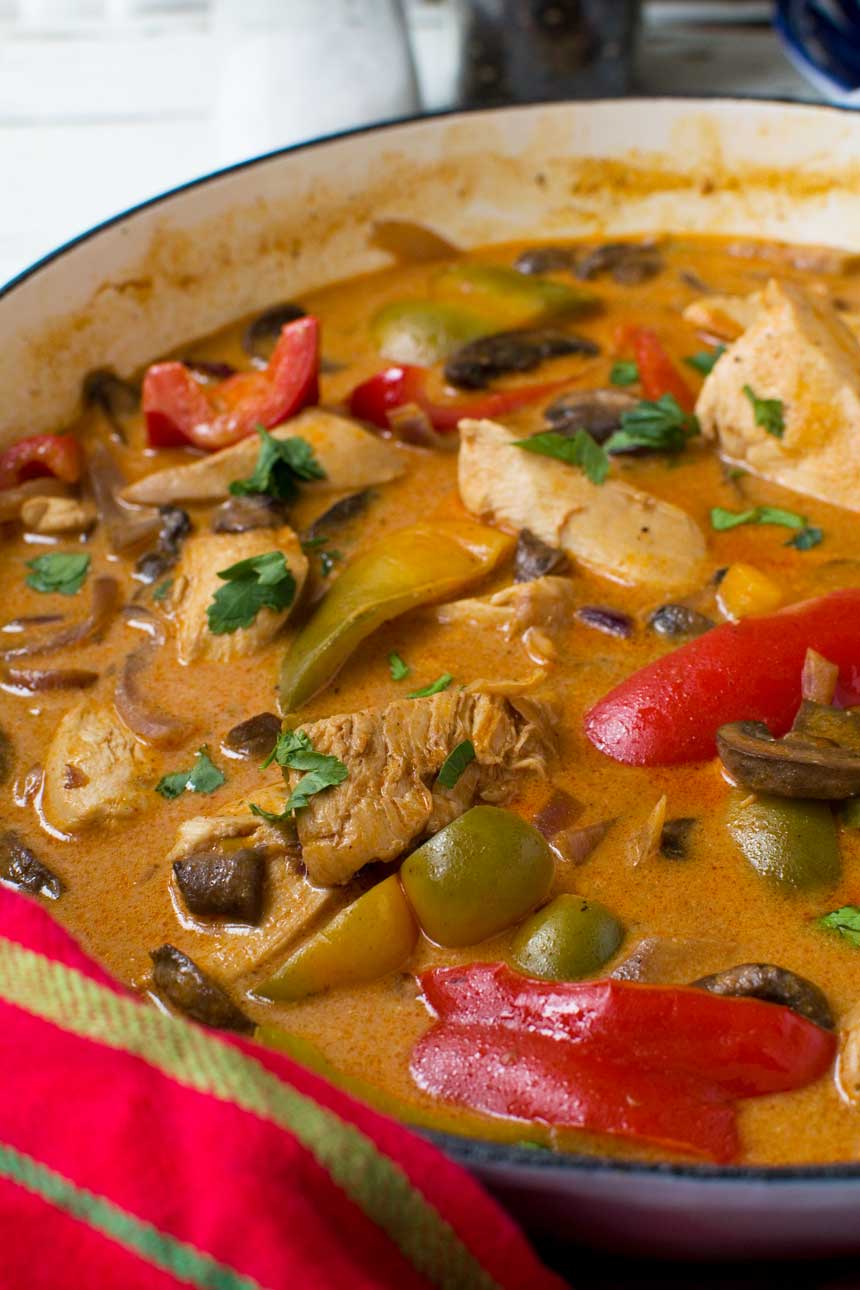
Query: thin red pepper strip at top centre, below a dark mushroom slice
349,364,570,431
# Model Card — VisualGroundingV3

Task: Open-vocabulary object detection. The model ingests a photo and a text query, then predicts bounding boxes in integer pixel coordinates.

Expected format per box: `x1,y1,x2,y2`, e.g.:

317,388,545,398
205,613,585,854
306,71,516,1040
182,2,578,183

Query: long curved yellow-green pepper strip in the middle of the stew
281,520,513,712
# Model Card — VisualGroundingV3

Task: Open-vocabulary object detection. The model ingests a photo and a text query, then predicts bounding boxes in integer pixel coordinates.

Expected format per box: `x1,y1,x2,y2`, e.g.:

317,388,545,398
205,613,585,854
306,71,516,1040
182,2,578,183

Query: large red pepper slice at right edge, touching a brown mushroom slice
585,587,860,766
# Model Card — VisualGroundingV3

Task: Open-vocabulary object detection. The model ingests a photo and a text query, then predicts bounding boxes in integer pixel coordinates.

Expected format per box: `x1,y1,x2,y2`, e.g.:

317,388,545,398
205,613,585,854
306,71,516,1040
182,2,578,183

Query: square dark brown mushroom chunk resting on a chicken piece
173,846,266,925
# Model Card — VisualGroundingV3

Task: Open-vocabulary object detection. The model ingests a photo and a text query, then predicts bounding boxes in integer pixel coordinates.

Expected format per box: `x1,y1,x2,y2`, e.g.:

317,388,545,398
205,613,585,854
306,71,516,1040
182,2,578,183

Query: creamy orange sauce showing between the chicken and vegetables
0,237,860,1164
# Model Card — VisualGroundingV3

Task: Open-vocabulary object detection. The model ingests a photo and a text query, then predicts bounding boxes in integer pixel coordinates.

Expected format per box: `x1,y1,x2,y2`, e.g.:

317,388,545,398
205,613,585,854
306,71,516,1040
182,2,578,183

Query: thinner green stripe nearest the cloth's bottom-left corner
0,1143,263,1290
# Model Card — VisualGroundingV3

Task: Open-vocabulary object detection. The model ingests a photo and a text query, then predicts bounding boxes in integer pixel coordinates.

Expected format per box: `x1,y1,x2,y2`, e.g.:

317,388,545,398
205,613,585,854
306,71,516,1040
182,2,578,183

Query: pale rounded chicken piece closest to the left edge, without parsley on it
43,699,155,833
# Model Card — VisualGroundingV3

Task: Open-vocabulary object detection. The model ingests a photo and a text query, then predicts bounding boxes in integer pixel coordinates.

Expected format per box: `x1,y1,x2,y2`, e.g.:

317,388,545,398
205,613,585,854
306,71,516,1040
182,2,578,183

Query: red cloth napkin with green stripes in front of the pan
0,890,562,1290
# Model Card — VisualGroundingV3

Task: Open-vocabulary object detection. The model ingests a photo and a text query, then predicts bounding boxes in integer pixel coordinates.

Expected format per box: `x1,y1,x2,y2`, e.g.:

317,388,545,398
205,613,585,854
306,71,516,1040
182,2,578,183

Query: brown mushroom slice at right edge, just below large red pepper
717,721,860,801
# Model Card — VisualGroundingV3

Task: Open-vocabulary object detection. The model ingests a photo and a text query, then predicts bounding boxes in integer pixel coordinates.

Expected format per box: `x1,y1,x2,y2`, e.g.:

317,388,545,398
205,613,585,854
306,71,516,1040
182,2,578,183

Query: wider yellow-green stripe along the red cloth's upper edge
0,940,500,1290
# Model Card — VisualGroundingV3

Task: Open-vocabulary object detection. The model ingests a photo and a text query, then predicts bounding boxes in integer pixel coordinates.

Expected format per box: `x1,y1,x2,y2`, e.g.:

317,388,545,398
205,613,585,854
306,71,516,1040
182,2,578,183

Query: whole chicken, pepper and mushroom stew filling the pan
8,234,860,1165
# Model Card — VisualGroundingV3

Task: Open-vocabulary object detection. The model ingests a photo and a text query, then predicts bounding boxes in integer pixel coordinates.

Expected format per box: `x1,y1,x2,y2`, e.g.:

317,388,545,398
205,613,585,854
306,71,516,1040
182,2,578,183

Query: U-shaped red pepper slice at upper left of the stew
142,317,320,452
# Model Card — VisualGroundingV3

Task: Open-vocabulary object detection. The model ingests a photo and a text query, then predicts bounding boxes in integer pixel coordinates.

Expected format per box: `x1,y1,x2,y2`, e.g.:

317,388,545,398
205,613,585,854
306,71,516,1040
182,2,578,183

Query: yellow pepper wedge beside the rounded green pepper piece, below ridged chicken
257,873,418,1004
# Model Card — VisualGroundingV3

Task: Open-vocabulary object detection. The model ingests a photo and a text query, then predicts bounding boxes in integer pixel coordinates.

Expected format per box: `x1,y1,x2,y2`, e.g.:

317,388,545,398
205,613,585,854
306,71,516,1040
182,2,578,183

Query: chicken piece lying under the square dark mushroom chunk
166,775,345,983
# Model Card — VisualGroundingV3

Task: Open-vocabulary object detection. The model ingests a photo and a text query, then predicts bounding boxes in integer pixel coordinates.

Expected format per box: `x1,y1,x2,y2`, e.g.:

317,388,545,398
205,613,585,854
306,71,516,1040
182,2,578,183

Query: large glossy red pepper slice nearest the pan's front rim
411,964,836,1162
